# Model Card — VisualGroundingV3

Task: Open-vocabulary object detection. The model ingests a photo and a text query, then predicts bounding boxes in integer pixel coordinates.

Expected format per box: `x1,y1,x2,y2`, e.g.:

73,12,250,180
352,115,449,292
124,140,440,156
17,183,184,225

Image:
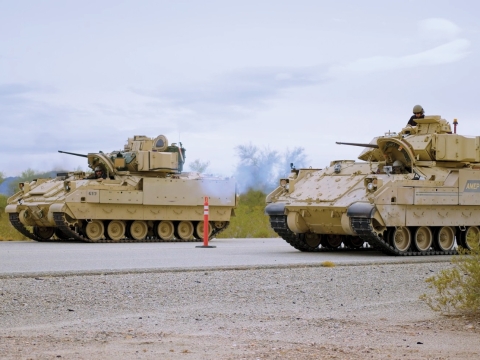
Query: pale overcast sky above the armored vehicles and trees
0,0,480,176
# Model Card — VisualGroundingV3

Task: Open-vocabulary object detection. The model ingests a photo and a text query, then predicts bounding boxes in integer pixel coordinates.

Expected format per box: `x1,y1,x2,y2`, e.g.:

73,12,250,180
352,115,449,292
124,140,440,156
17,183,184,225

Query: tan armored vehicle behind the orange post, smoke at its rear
5,135,236,242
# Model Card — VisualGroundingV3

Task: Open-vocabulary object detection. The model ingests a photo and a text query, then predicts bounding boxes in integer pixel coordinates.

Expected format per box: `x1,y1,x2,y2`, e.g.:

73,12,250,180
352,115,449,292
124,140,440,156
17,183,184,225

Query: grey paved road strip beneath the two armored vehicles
0,238,451,276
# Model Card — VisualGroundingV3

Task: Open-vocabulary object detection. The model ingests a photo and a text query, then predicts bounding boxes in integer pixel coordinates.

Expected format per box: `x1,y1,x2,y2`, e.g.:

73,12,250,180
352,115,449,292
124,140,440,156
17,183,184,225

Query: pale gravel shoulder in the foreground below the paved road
0,263,480,359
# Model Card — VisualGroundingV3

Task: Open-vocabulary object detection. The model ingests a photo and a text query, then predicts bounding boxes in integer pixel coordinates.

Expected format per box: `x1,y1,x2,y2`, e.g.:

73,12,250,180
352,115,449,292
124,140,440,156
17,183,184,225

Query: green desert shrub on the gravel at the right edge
420,245,480,316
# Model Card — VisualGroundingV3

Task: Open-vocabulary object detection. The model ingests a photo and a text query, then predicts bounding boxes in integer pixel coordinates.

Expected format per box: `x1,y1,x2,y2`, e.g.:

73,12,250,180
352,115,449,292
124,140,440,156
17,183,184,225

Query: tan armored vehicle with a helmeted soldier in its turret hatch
265,116,480,255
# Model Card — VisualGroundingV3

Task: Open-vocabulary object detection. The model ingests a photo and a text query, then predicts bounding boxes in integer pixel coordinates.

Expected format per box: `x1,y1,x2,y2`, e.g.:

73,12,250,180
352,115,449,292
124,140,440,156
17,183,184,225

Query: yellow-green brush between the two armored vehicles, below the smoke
217,189,278,238
